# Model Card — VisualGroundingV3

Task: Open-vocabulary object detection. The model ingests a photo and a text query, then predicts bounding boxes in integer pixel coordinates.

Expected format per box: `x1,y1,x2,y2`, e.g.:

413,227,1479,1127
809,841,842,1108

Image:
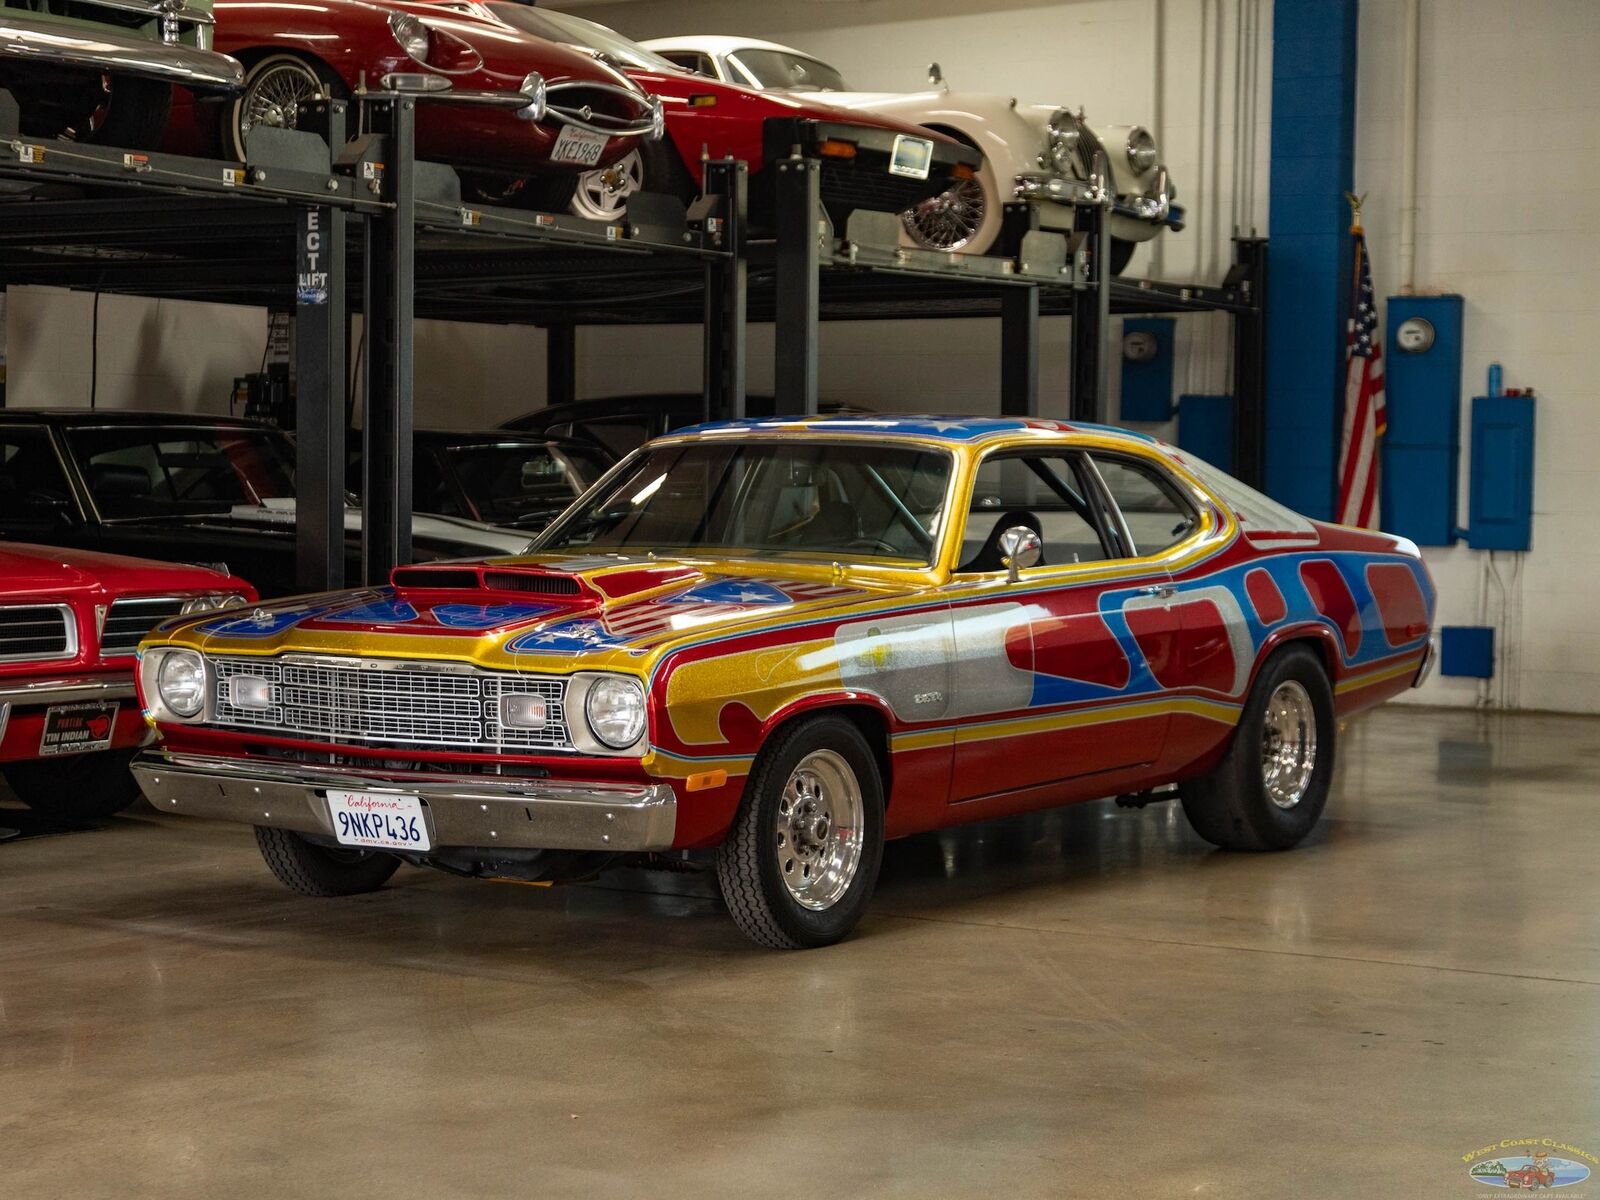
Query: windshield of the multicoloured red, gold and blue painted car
534,442,952,566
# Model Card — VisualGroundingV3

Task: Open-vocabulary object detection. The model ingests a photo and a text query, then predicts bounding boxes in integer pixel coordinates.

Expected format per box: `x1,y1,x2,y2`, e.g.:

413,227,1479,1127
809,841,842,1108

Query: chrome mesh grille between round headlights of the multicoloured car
206,658,573,754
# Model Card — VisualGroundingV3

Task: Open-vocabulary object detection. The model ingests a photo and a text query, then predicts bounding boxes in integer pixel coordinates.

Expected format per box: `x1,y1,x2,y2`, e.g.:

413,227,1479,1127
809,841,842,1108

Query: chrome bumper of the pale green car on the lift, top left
0,8,245,88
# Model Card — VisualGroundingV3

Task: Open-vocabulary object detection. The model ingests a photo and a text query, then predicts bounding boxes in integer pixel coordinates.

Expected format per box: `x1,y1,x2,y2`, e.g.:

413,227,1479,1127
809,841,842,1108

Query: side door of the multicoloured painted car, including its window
950,450,1178,800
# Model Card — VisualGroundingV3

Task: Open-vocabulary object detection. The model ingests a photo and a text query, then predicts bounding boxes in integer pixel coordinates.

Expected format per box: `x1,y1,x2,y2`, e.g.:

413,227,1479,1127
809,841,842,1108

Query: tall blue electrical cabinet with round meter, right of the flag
1379,296,1462,546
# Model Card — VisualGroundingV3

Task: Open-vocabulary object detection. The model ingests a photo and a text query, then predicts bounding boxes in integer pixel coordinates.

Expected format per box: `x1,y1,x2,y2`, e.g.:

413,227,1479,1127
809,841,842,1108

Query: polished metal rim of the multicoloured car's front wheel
773,750,864,910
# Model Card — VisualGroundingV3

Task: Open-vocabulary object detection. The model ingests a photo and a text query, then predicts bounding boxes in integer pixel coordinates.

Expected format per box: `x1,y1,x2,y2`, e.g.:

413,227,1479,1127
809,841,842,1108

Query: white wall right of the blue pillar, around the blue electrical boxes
1355,0,1600,712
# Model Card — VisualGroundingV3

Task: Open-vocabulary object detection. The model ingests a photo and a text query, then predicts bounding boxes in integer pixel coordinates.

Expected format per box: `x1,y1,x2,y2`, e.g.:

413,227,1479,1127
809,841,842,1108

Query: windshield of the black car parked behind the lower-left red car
66,426,294,520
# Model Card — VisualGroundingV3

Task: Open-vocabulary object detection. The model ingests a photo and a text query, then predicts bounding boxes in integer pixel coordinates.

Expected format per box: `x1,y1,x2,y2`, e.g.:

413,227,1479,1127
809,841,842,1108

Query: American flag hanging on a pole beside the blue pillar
1339,226,1389,530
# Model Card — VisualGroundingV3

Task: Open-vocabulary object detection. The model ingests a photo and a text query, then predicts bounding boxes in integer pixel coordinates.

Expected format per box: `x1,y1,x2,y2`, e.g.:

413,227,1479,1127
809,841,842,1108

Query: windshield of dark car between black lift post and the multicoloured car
445,442,611,526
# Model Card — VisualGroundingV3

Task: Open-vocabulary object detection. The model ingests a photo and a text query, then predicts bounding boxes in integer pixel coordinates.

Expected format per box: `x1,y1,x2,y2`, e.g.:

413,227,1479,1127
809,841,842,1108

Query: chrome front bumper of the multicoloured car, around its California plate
133,749,678,851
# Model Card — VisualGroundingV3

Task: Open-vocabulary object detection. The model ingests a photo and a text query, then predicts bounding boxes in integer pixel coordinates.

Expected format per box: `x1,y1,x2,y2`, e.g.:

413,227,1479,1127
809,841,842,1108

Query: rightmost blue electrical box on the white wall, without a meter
1467,395,1533,550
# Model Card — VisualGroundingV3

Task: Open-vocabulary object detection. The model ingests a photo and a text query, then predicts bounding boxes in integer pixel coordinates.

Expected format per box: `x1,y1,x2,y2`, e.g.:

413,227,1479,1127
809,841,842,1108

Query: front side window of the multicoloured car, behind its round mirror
955,451,1110,573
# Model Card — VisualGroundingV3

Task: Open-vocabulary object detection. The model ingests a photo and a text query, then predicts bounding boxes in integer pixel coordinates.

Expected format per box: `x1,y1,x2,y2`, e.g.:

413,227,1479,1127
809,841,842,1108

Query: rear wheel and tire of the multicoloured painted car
1179,645,1338,850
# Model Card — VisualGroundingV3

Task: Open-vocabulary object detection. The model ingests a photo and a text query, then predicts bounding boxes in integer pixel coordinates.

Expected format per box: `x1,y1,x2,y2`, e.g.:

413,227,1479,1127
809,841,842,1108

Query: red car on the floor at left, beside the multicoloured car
0,542,256,818
